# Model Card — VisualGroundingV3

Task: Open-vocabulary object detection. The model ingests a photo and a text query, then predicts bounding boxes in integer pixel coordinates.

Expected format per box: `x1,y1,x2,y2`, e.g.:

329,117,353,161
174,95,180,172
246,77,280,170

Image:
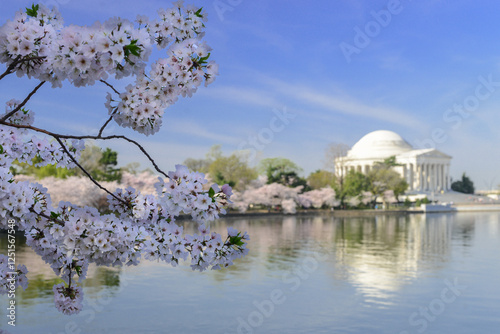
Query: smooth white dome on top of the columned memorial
347,130,413,159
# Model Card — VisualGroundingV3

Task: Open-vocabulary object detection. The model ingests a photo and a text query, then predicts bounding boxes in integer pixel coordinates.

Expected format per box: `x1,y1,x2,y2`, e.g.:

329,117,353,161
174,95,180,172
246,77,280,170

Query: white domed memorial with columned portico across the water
335,130,451,192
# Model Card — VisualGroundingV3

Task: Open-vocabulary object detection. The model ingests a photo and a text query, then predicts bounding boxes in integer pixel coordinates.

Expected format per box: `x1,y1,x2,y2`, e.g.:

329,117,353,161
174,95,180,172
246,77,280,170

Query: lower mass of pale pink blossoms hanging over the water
1,160,249,314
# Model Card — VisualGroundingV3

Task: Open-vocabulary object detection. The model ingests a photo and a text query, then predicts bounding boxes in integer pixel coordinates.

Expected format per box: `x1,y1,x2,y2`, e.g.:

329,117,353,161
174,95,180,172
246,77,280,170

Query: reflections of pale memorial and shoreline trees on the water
0,214,476,304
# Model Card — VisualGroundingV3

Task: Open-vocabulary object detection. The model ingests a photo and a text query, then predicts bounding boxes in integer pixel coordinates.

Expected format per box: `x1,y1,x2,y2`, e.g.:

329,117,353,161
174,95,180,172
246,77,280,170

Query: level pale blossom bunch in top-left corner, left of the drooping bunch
0,5,151,87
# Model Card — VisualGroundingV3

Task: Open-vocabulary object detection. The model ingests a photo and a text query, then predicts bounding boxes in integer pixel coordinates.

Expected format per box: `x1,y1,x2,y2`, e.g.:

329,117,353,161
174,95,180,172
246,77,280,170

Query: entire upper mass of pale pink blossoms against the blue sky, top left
0,2,218,135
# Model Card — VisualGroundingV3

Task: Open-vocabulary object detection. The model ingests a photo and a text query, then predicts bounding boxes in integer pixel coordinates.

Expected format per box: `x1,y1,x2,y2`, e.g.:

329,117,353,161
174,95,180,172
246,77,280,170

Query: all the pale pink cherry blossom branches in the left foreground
0,1,248,314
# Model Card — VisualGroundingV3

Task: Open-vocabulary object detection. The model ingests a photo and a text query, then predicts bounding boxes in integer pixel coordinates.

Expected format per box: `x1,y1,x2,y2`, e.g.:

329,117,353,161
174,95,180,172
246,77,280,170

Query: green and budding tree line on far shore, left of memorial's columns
184,145,408,207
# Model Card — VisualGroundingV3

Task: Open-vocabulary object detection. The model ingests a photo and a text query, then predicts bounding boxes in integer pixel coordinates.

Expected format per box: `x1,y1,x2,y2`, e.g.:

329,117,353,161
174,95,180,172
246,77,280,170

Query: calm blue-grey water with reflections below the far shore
0,213,500,334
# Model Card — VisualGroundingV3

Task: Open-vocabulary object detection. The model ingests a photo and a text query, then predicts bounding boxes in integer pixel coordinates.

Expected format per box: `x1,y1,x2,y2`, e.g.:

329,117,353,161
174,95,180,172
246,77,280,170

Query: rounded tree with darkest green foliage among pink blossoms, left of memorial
259,158,308,190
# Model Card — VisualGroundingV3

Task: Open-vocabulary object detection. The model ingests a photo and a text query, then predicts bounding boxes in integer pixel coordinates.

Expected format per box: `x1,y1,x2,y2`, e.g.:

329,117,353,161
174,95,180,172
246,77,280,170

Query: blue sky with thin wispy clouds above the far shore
0,0,500,189
